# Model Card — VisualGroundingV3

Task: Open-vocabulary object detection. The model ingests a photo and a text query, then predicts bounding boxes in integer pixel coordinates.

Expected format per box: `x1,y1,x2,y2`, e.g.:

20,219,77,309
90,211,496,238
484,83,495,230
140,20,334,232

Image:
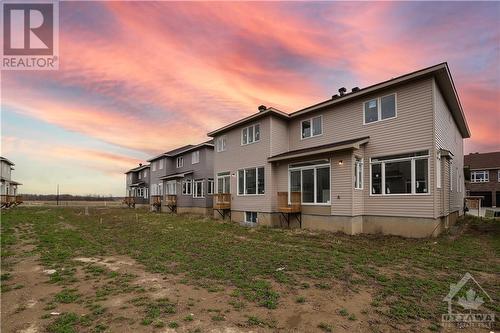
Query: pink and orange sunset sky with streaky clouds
0,2,500,196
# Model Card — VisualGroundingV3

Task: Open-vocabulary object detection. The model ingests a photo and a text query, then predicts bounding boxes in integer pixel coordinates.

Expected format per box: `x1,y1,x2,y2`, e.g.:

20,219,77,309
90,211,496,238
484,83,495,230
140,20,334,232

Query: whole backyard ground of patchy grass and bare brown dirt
1,207,500,333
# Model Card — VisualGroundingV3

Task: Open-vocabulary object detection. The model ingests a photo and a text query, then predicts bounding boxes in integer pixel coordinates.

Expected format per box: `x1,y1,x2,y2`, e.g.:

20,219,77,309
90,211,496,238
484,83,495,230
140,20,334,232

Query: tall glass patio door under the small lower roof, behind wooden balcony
289,160,330,204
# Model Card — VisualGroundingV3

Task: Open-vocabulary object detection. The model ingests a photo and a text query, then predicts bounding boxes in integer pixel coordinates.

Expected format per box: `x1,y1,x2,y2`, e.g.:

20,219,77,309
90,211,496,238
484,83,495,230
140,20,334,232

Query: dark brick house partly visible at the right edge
464,152,500,207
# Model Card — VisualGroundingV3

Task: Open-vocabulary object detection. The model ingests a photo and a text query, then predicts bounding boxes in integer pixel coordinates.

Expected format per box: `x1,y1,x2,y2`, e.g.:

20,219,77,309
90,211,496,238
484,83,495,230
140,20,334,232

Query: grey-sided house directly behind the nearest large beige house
148,141,214,214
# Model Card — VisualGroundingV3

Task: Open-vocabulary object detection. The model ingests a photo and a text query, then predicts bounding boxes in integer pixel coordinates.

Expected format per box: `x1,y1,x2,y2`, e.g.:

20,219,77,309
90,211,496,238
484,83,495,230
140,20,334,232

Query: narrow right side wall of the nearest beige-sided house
432,82,465,217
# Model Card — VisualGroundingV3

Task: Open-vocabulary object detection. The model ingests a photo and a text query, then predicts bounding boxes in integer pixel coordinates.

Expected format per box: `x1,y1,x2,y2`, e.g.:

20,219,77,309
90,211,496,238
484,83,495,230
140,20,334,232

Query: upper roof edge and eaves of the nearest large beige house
208,62,470,138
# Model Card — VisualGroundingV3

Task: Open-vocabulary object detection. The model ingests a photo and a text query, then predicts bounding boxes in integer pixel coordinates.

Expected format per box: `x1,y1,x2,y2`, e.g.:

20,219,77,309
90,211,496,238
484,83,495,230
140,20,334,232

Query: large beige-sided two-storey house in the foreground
208,63,470,237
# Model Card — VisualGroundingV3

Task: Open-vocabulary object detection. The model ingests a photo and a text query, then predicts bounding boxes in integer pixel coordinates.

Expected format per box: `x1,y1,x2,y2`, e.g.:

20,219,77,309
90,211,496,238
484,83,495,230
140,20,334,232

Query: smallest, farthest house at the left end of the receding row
124,163,150,207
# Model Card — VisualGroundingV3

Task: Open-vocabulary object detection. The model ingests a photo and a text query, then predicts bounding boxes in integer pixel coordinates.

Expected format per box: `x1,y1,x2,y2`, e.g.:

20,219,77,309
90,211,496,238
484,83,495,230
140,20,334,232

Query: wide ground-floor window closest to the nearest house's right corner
370,151,429,195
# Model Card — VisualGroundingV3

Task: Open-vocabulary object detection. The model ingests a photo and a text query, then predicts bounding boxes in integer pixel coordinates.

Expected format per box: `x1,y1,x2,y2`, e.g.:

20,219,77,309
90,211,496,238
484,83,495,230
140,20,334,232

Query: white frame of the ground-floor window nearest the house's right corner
369,150,431,197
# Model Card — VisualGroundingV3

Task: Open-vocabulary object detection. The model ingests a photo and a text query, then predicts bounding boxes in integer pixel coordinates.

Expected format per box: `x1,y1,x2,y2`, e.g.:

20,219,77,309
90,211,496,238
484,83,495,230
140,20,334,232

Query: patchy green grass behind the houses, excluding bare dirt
1,207,500,329
